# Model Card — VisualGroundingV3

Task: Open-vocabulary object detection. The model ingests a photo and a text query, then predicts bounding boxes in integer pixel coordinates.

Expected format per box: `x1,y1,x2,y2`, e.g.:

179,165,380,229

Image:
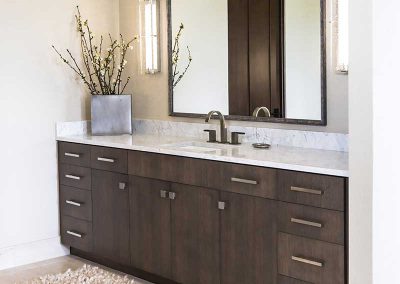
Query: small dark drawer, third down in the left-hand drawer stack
60,186,92,221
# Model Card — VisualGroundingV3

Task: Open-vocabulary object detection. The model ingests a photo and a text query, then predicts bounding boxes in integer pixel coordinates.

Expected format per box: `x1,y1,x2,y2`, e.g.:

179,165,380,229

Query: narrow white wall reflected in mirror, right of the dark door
285,0,321,120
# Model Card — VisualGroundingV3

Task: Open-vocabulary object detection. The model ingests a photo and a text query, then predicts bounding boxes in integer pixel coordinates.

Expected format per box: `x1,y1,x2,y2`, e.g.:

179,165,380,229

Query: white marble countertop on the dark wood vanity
57,134,349,177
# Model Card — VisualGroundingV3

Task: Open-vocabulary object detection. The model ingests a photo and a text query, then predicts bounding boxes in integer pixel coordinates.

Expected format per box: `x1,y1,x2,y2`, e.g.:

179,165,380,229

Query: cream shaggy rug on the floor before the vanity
25,264,135,284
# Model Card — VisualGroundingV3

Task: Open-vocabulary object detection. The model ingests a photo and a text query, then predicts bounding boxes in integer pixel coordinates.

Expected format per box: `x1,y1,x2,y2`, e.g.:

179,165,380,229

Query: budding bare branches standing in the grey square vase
52,6,137,95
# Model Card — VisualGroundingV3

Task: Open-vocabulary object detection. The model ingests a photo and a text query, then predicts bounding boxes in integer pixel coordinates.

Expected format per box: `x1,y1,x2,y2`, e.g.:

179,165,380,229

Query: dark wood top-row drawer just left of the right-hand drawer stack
207,162,277,199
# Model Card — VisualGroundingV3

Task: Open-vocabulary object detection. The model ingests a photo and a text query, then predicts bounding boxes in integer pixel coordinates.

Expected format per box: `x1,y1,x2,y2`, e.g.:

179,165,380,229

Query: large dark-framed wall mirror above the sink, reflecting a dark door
168,0,326,125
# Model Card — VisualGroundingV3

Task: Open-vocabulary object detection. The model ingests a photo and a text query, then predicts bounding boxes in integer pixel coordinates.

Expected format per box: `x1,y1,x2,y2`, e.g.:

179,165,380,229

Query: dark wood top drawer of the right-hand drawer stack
278,171,345,211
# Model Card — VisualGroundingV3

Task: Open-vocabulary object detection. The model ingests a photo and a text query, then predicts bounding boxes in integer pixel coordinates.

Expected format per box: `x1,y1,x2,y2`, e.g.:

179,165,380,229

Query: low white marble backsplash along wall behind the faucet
56,119,348,152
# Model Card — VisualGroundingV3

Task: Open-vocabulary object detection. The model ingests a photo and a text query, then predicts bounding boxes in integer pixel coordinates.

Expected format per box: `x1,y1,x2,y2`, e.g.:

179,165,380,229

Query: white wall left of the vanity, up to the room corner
0,0,118,269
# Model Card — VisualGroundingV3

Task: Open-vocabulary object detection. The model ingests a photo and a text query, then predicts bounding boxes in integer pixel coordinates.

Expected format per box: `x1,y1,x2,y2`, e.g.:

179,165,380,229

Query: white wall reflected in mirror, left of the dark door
171,0,229,115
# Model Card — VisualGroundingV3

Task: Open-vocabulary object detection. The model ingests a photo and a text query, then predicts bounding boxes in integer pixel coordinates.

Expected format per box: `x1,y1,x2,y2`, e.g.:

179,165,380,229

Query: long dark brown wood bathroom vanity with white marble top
58,135,347,284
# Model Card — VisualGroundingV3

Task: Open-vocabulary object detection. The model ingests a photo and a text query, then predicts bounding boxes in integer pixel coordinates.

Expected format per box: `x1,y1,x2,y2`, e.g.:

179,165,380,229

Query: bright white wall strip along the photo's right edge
373,0,400,284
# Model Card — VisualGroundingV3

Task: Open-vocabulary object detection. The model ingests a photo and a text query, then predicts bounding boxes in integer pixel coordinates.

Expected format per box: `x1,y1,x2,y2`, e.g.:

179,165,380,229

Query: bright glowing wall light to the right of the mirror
336,0,349,73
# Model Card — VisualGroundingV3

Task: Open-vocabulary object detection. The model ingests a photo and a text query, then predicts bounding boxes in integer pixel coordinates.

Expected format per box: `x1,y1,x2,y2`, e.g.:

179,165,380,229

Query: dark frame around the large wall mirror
167,0,327,126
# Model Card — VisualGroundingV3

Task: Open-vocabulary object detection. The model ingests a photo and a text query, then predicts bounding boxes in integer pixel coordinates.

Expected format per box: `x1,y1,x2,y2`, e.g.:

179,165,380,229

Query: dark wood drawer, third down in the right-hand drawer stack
278,233,345,284
